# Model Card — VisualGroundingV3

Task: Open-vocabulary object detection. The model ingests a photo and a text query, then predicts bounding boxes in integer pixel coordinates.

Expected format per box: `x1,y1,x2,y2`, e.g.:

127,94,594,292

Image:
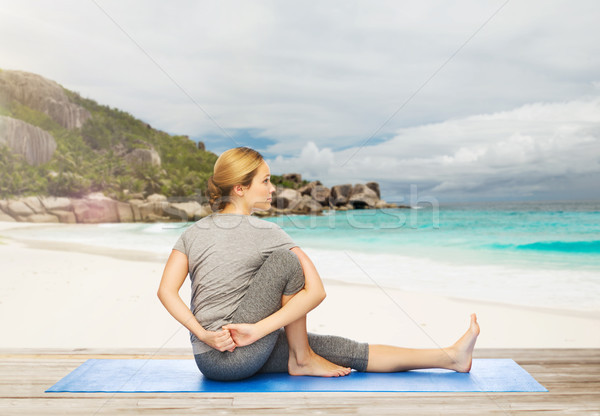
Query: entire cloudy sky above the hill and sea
0,0,600,202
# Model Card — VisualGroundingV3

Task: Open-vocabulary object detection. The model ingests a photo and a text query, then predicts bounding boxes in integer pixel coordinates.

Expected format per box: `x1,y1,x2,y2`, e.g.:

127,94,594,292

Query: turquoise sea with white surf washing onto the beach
2,201,600,313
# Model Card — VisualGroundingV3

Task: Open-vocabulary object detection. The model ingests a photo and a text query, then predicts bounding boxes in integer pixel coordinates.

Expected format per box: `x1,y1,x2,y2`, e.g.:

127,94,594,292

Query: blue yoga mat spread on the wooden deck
46,359,548,393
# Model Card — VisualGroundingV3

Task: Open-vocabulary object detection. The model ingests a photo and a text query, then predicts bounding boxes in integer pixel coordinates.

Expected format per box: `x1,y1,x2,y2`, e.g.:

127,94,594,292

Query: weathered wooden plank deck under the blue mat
0,349,600,416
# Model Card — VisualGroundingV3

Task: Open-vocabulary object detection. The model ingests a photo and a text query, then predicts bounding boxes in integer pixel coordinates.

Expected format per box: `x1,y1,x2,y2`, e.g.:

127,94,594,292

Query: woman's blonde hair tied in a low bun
207,147,264,211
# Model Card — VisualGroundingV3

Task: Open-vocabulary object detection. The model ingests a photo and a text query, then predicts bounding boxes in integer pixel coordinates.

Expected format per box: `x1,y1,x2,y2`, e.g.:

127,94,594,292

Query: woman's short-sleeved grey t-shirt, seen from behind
173,213,296,354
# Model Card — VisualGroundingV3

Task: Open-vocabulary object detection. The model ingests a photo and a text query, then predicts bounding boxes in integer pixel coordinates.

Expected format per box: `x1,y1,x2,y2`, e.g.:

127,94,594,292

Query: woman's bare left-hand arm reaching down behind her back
157,250,235,351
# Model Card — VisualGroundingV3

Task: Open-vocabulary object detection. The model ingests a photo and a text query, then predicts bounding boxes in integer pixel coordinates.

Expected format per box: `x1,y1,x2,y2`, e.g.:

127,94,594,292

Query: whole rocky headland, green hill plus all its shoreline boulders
0,70,395,223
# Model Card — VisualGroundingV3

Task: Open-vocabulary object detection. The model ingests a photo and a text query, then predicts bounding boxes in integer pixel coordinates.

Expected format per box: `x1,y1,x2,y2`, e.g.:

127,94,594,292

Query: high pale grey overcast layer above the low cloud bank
0,0,600,150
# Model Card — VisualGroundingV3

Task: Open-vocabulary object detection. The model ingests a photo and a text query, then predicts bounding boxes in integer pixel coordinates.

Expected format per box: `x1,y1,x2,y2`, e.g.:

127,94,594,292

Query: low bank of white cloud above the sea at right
271,98,600,199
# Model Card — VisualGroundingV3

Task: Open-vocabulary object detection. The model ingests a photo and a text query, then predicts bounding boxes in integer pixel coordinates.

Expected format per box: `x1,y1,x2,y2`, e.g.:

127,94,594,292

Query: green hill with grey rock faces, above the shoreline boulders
0,70,217,201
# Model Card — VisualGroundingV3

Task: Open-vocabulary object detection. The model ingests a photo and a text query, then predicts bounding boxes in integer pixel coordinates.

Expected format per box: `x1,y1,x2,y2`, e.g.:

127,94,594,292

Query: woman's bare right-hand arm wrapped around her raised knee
223,247,326,347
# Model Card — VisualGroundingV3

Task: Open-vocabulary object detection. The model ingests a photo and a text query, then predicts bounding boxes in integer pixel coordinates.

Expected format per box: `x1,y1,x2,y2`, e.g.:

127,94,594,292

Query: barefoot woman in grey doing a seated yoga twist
158,147,479,380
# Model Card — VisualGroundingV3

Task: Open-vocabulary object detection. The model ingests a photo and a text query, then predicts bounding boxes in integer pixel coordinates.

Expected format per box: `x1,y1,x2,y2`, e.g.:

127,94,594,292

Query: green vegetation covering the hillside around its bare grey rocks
0,90,217,200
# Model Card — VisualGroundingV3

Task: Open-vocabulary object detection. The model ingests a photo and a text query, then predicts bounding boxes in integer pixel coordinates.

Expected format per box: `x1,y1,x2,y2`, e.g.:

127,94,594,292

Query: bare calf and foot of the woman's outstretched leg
367,314,479,373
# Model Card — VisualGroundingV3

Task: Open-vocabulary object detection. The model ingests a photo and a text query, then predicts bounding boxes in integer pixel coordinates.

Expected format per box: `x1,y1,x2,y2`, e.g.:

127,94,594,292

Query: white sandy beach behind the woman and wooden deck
0,223,600,352
